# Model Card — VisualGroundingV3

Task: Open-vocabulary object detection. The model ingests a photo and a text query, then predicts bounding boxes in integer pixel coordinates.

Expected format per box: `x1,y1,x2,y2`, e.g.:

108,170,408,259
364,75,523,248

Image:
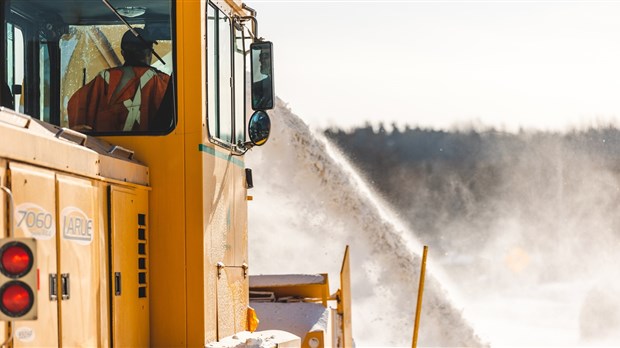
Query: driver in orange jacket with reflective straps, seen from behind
67,28,170,132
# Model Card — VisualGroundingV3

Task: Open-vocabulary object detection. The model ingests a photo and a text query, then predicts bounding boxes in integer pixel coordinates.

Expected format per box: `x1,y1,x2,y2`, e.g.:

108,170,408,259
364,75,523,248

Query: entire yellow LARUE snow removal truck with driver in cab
0,0,352,347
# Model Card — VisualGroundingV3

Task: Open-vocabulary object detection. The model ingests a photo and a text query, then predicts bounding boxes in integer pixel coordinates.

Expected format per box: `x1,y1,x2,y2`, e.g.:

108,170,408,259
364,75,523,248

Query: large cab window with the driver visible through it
0,0,175,134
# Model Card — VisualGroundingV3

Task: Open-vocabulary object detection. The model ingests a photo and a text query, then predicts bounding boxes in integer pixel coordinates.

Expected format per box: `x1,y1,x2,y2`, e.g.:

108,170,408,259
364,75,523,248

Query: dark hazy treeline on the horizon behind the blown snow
324,125,620,254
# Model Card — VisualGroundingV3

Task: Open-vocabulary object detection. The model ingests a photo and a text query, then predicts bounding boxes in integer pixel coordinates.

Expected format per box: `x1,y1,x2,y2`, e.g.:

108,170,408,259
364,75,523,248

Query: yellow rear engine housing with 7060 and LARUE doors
0,119,149,347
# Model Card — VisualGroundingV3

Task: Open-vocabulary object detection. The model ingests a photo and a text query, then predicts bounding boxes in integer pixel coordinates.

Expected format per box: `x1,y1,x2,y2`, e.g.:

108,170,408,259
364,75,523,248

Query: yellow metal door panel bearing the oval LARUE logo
57,174,100,347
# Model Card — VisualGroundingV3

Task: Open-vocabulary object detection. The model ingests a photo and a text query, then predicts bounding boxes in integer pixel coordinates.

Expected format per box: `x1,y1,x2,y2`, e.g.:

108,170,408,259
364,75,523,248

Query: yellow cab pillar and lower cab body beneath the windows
98,1,248,347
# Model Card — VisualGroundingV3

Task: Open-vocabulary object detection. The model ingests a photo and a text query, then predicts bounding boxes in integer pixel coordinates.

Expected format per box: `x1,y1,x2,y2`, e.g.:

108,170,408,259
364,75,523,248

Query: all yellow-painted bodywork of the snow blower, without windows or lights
0,0,350,347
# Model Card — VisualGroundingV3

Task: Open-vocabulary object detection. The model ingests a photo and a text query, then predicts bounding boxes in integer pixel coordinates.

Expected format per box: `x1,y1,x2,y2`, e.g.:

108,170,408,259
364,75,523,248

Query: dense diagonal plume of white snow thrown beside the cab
246,101,484,347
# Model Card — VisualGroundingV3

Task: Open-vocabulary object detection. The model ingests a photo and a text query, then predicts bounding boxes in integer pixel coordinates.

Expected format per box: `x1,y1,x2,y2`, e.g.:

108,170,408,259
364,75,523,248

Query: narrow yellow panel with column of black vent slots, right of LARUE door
110,186,148,347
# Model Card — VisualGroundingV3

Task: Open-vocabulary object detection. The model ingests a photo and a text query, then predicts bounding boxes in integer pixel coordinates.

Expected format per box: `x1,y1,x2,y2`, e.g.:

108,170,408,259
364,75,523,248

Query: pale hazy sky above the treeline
247,0,620,130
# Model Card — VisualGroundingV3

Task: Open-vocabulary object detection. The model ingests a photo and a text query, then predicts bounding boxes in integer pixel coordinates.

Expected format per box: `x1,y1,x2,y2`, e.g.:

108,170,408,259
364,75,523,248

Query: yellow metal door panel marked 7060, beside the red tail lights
9,162,58,347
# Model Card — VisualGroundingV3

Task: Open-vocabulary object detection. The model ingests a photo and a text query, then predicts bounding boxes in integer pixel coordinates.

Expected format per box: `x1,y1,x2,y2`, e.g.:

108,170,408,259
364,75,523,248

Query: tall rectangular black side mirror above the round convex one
250,41,274,110
